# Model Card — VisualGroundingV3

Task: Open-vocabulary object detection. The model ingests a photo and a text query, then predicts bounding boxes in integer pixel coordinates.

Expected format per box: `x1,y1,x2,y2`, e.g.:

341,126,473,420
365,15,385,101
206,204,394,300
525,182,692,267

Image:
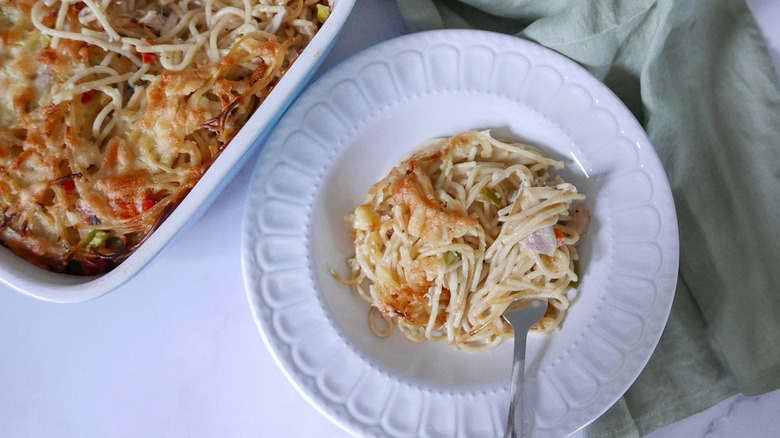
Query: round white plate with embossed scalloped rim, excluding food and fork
242,30,678,438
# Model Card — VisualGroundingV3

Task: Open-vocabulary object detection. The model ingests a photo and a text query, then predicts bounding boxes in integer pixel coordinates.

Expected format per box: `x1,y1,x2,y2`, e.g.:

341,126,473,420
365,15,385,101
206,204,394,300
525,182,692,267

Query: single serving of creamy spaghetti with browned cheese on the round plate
334,131,590,350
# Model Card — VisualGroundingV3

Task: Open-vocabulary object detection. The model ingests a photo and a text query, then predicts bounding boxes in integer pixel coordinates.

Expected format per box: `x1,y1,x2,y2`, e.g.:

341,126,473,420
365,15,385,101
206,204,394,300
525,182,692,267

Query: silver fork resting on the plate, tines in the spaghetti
504,300,547,438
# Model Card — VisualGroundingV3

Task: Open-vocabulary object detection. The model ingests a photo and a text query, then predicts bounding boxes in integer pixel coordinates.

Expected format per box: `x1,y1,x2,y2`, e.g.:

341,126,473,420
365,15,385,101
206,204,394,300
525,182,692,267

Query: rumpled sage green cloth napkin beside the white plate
397,0,780,436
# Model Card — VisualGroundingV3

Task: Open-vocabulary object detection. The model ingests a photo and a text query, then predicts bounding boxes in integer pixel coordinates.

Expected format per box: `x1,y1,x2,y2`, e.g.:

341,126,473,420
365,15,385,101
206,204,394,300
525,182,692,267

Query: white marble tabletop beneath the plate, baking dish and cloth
0,0,780,438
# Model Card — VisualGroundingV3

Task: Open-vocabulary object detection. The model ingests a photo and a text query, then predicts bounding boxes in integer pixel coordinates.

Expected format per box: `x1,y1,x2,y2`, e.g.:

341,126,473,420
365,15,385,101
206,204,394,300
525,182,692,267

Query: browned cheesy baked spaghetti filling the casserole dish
0,0,323,274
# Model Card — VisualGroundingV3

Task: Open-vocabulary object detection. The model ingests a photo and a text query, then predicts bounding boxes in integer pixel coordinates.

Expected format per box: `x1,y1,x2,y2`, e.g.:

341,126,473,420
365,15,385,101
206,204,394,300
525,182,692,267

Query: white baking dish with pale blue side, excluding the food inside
0,0,355,303
